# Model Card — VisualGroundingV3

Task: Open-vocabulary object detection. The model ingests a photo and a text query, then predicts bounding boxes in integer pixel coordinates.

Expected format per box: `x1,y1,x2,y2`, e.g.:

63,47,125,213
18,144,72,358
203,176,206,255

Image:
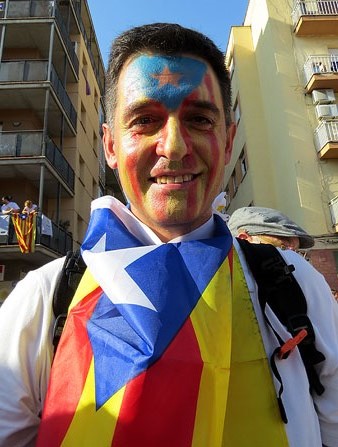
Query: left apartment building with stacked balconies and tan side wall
0,0,105,300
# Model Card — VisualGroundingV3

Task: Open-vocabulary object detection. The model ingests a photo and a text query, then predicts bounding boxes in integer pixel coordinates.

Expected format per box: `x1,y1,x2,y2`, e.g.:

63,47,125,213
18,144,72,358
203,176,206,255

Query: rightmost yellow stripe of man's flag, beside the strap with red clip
222,253,289,447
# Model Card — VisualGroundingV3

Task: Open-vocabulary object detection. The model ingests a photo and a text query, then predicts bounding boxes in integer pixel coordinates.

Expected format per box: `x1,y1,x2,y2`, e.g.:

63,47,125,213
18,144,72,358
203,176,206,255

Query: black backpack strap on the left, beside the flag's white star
53,250,86,353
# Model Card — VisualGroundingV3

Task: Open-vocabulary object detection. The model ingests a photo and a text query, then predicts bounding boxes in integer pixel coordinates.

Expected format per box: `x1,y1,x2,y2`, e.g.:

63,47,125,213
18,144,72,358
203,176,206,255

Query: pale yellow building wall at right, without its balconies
225,0,338,284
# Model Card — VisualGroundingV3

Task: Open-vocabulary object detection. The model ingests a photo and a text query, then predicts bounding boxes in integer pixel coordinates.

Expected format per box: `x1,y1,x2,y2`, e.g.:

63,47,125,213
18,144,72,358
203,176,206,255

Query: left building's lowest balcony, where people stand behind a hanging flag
0,215,73,262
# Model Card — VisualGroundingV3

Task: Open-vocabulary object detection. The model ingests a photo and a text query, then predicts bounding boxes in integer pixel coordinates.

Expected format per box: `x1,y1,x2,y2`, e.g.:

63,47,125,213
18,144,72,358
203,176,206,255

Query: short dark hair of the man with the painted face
105,23,231,124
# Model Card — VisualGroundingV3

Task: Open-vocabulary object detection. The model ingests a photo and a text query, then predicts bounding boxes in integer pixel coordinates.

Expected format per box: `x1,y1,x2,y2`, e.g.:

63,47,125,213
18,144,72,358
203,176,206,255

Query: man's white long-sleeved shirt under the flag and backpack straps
0,197,338,447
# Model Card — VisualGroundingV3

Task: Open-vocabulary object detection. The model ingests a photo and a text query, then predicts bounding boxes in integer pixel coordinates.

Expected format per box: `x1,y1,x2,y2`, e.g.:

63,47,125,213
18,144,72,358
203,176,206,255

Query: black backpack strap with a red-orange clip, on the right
237,239,325,420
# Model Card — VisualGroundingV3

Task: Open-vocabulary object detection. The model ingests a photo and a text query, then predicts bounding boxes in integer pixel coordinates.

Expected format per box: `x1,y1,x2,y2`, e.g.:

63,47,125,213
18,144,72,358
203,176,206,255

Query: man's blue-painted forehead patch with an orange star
126,55,208,110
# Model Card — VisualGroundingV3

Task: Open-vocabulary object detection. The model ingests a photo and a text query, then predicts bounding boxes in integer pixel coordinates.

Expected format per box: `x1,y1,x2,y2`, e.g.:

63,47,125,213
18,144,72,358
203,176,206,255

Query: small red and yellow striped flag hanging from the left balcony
12,214,36,253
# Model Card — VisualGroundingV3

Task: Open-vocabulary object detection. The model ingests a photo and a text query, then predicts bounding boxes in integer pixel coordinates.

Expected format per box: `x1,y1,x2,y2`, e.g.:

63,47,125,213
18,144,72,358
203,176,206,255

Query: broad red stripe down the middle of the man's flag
112,319,203,447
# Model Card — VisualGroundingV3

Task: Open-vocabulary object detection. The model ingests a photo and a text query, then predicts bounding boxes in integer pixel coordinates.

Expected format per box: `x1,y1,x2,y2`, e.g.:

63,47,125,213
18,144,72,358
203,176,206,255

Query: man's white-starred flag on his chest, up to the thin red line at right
37,198,287,447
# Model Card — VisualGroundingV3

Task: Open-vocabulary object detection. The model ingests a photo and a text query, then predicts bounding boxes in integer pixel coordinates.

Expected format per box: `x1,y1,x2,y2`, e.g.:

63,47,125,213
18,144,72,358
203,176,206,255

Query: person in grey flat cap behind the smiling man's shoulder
228,206,314,251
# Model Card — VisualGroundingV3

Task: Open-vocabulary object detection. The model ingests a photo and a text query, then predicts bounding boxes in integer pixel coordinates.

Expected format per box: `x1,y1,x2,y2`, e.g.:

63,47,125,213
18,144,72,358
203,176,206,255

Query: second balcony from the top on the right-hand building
304,54,338,93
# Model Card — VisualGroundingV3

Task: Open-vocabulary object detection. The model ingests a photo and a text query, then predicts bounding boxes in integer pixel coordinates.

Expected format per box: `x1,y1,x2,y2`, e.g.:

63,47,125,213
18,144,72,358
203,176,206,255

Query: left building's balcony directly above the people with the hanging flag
0,131,75,195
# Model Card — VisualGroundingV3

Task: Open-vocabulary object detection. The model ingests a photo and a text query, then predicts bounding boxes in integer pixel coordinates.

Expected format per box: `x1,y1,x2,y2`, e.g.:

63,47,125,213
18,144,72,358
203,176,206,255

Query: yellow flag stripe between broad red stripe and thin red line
191,258,232,447
